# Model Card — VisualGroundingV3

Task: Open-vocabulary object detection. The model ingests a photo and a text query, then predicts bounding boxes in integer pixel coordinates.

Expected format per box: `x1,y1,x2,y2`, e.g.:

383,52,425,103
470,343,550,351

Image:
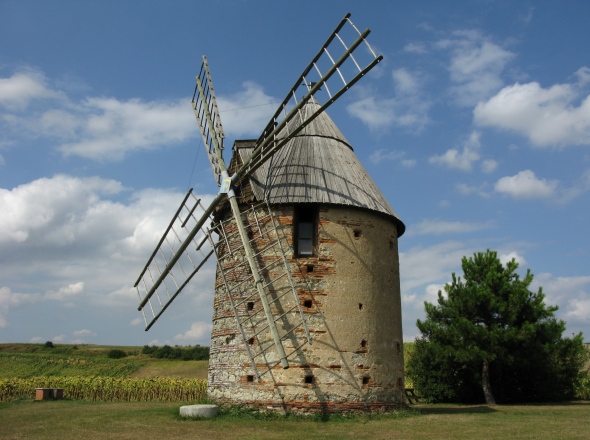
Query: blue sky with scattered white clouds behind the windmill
0,0,590,345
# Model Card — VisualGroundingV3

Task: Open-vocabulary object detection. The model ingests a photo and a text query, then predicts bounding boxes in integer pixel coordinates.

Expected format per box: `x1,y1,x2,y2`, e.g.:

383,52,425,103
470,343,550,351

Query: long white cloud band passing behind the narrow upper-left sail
0,71,277,161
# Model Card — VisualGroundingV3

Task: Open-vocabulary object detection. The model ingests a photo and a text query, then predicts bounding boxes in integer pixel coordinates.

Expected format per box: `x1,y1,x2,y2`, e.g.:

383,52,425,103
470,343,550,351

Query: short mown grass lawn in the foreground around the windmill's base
0,400,590,440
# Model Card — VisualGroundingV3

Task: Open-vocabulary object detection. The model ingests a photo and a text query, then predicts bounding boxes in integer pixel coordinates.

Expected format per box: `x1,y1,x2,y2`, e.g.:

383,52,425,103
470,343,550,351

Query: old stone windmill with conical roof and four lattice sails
135,14,405,411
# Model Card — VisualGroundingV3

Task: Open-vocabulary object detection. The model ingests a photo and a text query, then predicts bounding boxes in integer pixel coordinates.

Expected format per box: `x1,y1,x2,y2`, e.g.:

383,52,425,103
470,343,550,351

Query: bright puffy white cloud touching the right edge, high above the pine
473,75,590,147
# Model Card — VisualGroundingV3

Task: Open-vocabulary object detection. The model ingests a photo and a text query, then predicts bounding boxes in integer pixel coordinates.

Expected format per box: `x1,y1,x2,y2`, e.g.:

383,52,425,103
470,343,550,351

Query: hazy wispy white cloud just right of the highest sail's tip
436,31,514,107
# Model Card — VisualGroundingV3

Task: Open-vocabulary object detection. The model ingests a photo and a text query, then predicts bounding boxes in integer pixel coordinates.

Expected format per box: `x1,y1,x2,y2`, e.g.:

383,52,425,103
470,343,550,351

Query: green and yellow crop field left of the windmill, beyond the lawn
0,344,207,402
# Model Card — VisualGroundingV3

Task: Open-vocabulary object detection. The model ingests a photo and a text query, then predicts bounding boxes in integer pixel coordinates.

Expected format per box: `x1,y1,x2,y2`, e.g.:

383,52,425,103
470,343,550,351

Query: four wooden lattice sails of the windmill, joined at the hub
135,14,382,368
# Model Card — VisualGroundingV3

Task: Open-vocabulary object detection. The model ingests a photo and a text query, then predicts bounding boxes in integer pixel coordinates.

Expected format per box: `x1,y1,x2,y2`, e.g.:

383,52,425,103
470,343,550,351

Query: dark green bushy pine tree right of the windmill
407,250,587,405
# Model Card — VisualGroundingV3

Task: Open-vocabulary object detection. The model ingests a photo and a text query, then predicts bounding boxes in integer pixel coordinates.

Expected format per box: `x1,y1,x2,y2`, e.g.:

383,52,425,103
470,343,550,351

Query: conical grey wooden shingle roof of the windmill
234,103,405,236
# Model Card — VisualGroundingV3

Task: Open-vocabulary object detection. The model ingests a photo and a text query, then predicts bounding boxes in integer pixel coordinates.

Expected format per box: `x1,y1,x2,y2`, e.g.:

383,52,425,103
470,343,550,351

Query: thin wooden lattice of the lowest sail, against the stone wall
213,202,312,379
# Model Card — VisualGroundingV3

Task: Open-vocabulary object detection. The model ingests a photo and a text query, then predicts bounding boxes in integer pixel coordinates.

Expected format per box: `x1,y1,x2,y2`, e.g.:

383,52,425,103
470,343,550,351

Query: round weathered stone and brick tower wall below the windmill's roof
208,206,404,411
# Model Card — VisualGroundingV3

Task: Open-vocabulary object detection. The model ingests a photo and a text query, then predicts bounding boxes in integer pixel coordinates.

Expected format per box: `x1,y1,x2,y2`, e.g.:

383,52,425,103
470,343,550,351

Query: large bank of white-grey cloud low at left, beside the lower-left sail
0,175,214,326
